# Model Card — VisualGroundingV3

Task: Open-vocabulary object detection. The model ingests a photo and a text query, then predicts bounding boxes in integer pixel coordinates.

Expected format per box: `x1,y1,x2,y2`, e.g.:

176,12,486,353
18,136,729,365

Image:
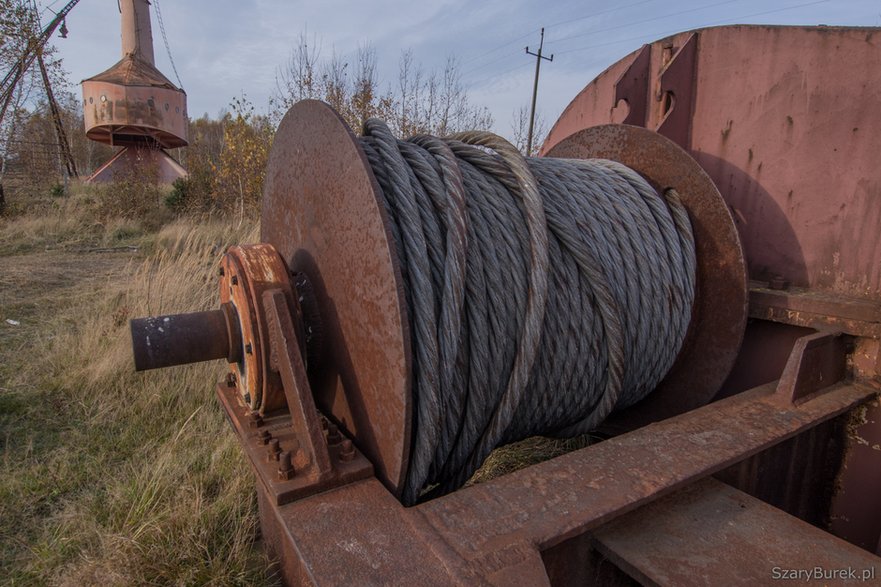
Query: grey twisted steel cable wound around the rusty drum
361,119,696,504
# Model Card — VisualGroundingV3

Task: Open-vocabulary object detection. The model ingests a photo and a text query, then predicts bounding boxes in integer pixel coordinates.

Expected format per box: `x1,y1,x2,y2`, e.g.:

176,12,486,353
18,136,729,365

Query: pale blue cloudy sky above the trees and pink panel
42,0,881,134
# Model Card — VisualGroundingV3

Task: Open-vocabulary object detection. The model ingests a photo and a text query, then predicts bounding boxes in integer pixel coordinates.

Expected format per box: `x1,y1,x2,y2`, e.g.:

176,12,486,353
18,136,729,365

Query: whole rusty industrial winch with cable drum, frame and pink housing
132,27,881,585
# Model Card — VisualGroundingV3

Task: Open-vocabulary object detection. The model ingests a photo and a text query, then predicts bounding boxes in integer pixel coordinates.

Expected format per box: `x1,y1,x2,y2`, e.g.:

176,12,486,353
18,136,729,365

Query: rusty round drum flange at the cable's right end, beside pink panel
547,124,748,432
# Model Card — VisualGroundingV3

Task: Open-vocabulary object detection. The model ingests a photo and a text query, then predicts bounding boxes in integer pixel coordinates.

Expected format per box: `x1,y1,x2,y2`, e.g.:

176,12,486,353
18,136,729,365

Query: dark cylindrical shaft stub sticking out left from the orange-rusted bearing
130,309,241,371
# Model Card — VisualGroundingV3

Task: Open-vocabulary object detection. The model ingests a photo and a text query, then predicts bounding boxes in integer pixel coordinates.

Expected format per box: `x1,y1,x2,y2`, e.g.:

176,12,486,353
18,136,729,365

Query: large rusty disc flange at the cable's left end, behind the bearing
261,100,412,494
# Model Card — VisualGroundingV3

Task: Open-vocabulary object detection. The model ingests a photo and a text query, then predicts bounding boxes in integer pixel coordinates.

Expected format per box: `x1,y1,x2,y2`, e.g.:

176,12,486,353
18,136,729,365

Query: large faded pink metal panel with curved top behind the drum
544,26,881,299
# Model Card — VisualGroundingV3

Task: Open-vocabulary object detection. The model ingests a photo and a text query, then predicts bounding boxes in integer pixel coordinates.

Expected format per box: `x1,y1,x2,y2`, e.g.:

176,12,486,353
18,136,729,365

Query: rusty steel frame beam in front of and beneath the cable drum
218,333,881,585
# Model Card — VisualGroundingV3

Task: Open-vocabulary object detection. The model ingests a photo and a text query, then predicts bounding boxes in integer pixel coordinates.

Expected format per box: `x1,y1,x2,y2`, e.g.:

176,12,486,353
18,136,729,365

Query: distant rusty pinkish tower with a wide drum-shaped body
82,0,188,183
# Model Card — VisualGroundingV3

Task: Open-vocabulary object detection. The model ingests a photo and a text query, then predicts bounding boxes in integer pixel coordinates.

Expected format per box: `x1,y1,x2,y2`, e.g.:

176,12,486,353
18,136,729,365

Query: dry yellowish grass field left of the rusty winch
0,199,273,585
